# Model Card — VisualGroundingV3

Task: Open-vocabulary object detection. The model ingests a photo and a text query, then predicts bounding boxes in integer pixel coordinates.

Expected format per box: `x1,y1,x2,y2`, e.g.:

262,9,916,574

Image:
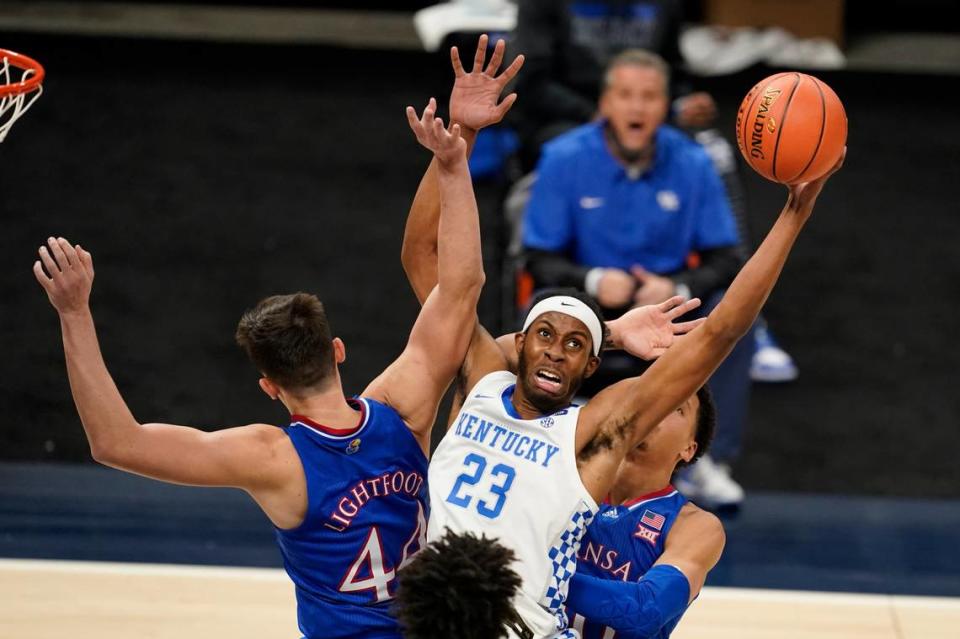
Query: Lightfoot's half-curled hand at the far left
33,237,93,315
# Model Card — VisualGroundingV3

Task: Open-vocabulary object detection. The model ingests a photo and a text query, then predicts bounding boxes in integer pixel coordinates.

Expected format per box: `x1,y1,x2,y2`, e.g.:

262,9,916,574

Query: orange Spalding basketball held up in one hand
737,71,847,184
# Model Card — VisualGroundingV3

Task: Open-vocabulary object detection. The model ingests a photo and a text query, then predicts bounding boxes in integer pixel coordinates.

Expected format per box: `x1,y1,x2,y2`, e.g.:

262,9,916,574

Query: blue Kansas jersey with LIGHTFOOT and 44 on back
276,398,429,639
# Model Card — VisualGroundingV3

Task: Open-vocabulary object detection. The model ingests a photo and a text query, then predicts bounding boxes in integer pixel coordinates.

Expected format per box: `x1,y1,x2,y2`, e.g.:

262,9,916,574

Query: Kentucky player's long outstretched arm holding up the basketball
577,152,843,496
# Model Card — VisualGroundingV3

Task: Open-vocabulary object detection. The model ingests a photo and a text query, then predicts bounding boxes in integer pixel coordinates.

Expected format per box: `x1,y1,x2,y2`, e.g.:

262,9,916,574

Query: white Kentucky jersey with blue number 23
427,371,597,638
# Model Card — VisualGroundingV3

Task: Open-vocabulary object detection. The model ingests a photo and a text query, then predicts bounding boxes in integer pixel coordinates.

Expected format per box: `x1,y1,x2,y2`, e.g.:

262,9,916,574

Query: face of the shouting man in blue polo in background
600,65,668,153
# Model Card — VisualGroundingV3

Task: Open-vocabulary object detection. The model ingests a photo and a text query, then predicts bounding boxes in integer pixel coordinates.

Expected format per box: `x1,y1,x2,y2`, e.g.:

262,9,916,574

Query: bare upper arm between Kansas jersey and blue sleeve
655,504,727,601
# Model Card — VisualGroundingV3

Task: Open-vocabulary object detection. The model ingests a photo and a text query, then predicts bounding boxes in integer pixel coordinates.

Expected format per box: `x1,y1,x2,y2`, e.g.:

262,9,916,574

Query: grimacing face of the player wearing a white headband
518,312,593,411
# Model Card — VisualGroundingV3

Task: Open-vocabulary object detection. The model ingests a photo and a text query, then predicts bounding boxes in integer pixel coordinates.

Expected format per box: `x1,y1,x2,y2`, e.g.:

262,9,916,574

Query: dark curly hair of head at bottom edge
394,529,521,639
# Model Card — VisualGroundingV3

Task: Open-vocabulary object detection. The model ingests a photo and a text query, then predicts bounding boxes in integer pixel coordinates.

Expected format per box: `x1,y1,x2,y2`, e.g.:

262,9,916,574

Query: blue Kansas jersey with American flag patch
567,486,687,639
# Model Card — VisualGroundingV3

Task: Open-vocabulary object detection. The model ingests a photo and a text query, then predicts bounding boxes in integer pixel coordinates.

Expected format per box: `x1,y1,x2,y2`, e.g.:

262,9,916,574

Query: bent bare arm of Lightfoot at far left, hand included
33,238,296,514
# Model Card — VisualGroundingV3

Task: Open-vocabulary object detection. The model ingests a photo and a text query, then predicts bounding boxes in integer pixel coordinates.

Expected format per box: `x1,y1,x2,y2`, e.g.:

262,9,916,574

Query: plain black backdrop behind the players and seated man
0,34,960,497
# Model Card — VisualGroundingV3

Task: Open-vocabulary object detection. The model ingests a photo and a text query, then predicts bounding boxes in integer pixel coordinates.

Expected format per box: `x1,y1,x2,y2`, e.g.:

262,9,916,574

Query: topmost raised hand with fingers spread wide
450,34,523,131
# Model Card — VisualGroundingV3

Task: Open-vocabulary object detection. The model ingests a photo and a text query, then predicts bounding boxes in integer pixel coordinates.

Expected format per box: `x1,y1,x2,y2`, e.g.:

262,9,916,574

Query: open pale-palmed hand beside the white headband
608,295,706,360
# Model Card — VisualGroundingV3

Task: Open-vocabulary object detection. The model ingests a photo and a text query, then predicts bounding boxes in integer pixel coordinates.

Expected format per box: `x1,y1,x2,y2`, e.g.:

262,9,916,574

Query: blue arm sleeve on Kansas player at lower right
567,564,690,639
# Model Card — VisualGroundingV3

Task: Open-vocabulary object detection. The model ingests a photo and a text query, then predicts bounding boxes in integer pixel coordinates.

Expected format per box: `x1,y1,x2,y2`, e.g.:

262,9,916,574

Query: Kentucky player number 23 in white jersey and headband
394,57,842,639
